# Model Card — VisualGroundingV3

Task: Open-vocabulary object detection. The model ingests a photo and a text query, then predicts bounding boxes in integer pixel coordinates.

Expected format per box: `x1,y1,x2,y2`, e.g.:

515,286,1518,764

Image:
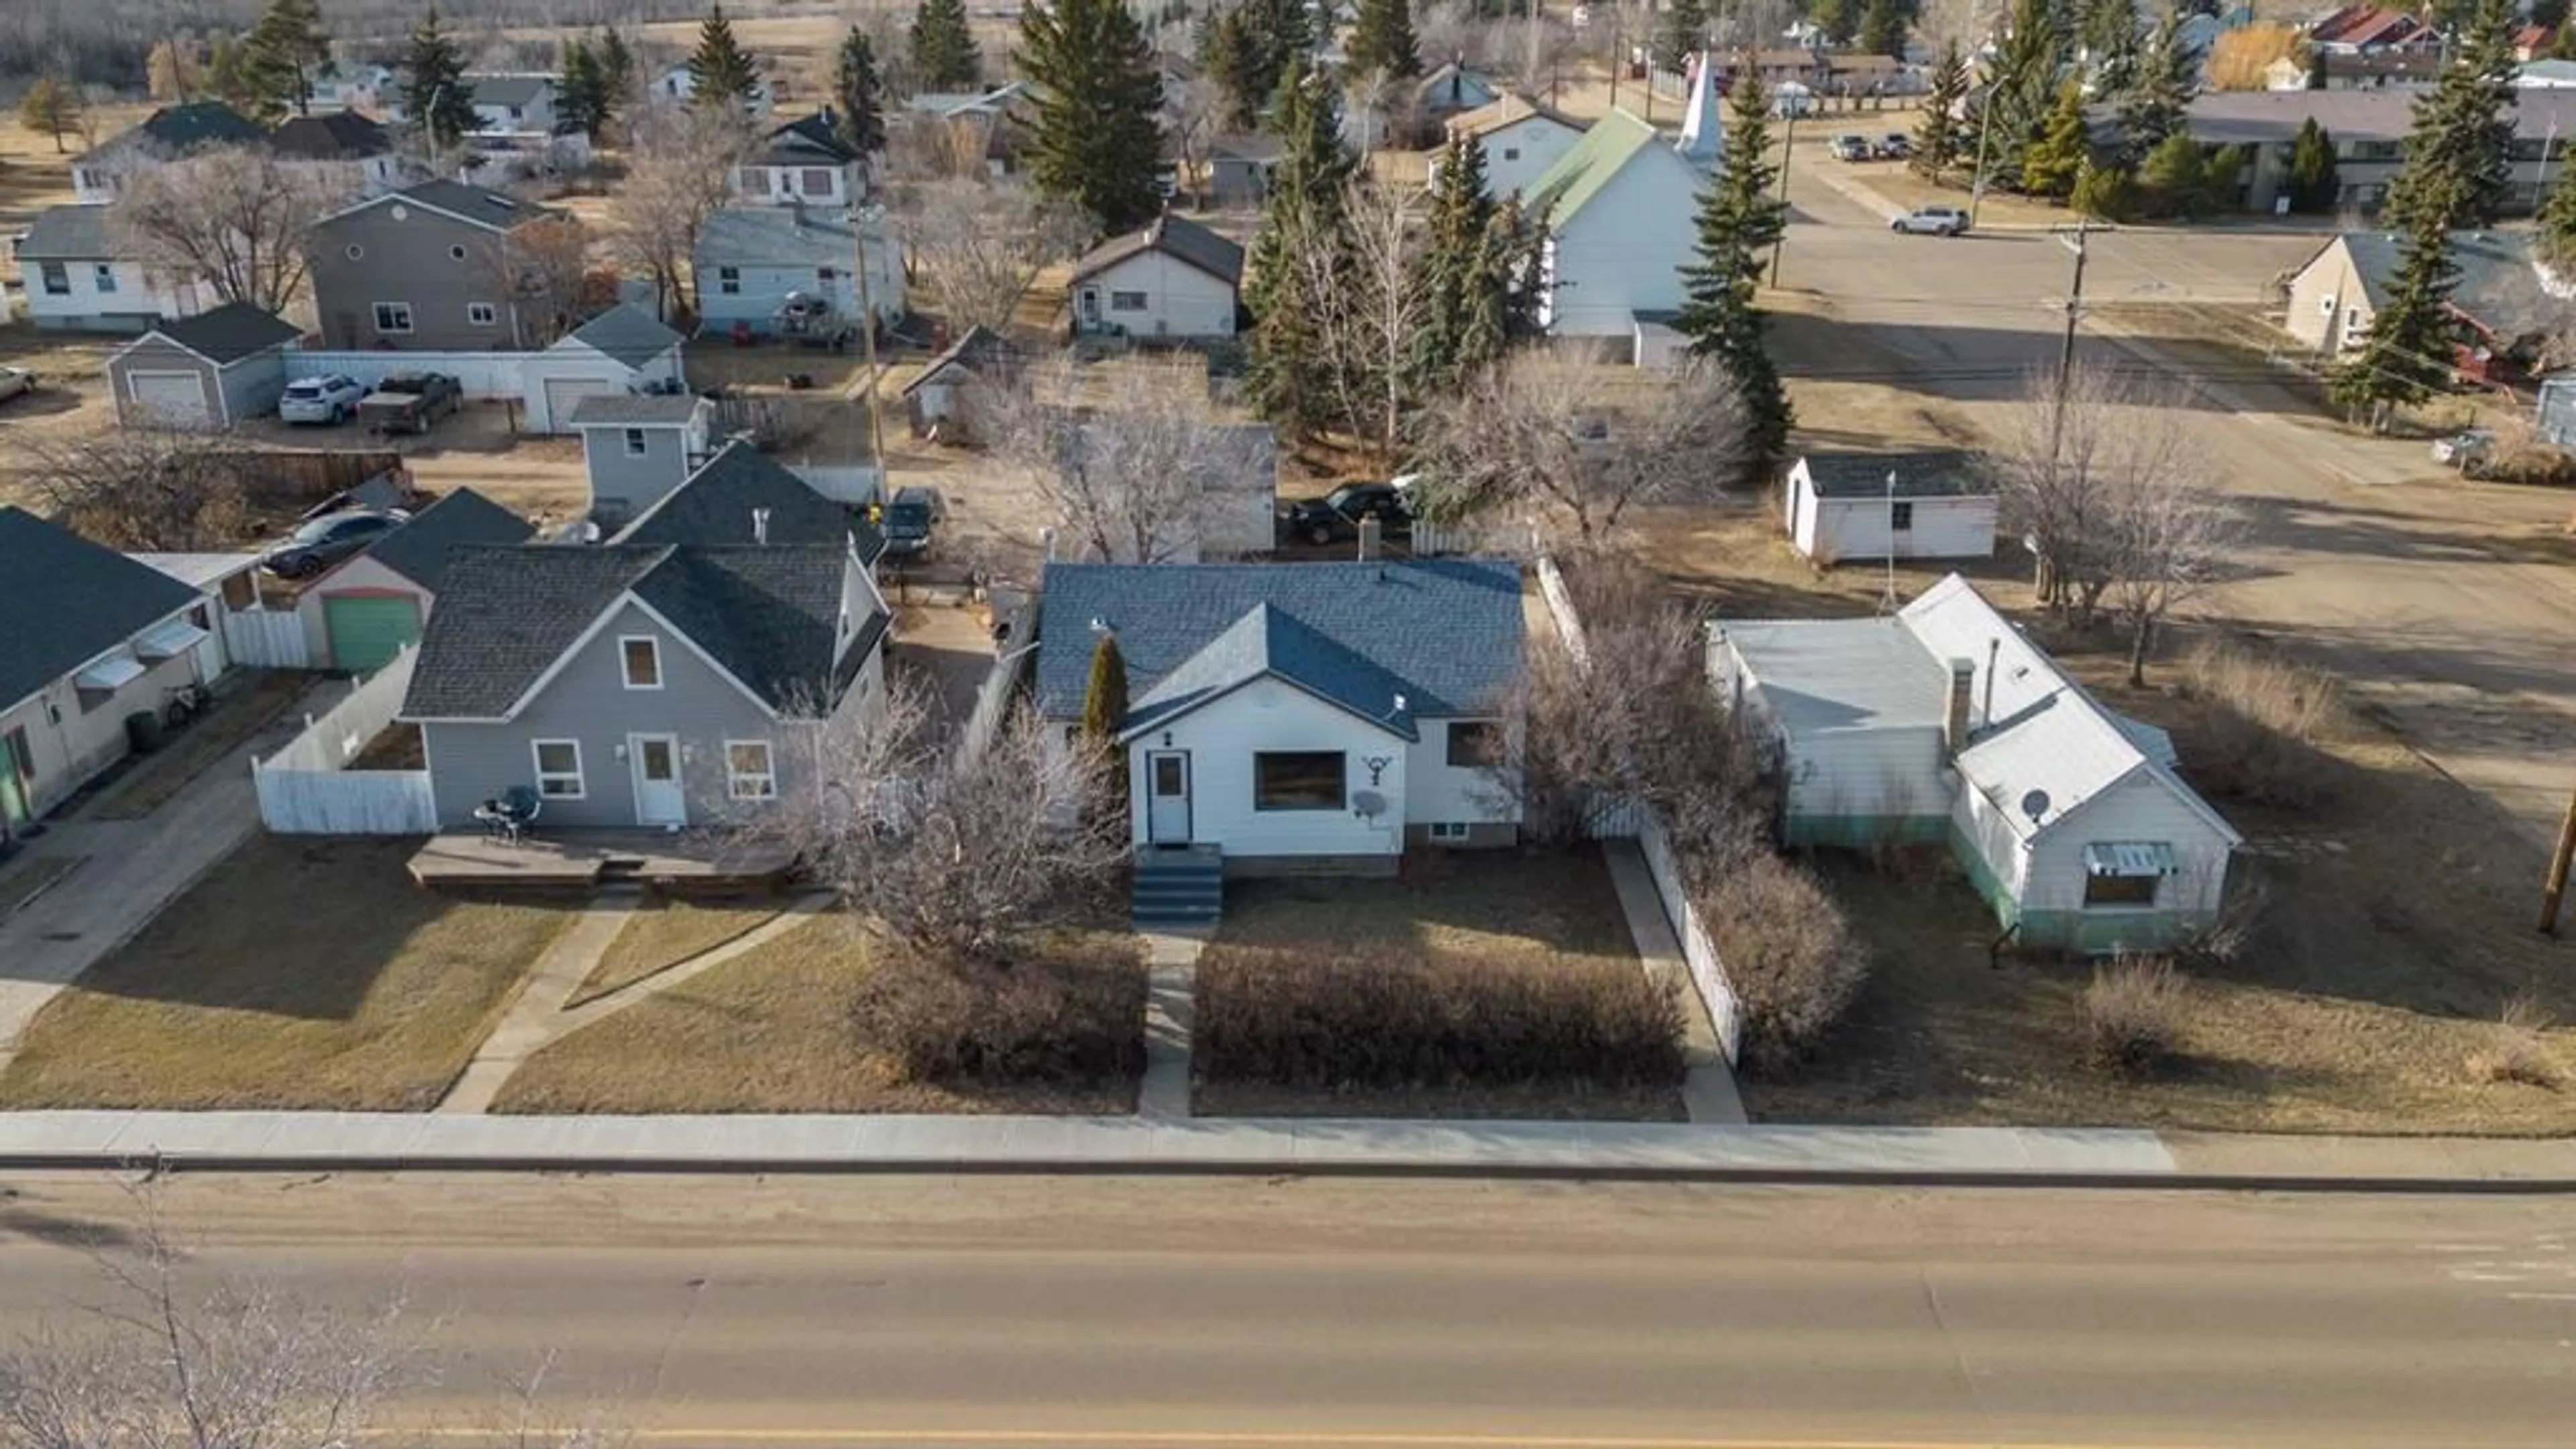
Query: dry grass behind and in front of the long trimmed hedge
1193,851,1682,1122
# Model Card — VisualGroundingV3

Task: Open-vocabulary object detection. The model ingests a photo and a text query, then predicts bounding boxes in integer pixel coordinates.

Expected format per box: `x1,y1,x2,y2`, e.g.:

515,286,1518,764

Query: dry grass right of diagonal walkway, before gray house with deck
494,918,1144,1114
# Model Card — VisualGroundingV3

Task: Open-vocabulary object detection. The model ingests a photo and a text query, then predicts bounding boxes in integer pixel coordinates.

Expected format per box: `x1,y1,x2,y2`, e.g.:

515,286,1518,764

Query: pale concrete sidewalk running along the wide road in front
0,1112,2576,1191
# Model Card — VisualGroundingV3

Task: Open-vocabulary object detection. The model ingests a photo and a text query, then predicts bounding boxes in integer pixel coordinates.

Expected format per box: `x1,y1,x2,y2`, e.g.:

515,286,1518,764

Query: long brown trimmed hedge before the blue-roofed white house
1190,949,1687,1088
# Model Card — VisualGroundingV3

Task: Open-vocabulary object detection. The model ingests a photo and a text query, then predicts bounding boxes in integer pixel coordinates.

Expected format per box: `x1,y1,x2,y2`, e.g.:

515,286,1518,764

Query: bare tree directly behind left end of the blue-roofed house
971,354,1254,565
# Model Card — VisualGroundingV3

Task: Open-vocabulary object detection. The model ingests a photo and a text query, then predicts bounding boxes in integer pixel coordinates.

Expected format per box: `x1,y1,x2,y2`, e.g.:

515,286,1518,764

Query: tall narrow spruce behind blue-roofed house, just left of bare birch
1244,57,1355,438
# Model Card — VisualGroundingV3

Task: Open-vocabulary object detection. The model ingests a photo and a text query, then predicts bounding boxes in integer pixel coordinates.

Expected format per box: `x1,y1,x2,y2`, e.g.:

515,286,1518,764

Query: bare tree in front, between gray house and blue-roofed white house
760,678,1126,959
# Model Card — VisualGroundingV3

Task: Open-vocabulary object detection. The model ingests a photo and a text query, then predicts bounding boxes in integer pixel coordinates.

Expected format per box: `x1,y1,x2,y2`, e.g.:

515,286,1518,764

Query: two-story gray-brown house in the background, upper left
307,180,580,354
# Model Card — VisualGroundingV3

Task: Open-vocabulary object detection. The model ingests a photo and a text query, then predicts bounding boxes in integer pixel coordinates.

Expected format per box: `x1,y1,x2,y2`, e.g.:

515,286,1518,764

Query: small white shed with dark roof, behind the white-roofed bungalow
1780,453,1996,568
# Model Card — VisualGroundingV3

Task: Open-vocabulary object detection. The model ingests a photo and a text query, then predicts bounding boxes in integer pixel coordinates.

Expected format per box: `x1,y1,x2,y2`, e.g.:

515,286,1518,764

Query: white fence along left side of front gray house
250,645,438,835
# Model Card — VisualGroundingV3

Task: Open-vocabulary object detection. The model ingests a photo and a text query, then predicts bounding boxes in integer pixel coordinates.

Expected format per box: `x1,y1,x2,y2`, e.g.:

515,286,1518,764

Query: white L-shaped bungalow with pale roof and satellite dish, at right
1708,575,2241,954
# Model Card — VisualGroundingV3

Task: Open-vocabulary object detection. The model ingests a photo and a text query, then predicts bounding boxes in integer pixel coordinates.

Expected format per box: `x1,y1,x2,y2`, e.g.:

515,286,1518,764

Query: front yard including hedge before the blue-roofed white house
1193,851,1682,1122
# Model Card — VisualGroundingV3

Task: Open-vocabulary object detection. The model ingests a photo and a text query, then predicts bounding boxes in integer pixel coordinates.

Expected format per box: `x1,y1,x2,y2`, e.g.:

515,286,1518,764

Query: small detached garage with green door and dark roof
297,487,536,673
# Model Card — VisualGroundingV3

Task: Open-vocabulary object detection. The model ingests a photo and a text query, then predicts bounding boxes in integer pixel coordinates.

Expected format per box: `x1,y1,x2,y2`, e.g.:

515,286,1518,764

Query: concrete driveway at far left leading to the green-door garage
0,681,347,1067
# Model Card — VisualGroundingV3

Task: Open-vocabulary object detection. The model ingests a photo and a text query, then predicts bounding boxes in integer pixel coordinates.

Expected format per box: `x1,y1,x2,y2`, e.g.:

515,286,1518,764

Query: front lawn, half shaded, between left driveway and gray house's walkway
0,835,572,1112
